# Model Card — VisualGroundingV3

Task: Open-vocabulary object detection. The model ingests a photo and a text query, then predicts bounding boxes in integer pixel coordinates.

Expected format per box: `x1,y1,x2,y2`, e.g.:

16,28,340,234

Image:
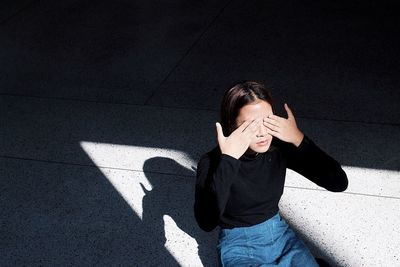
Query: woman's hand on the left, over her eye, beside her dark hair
216,119,261,159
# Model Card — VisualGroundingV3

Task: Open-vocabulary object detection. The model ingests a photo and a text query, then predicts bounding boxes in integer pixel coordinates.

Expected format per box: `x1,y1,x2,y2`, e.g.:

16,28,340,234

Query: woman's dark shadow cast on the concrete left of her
142,157,217,266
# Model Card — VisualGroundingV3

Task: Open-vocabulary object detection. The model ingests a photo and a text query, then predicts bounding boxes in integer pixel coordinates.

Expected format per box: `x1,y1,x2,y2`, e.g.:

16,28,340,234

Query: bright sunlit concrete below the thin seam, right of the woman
280,188,400,266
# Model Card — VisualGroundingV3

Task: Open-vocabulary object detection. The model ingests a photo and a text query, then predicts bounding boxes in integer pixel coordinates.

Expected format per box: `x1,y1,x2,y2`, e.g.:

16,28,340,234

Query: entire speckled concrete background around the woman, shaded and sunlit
0,0,400,267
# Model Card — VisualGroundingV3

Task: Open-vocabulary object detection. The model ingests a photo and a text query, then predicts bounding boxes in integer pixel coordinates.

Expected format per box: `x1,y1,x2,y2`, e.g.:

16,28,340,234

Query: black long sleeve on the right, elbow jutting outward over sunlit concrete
283,136,348,192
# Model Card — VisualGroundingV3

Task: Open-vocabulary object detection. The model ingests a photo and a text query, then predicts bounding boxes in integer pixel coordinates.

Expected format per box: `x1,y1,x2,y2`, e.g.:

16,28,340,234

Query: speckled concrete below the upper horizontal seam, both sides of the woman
0,96,400,266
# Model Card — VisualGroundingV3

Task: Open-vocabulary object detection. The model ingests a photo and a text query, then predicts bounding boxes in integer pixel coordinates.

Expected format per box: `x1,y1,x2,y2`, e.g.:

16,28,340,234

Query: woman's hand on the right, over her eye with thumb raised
263,103,304,147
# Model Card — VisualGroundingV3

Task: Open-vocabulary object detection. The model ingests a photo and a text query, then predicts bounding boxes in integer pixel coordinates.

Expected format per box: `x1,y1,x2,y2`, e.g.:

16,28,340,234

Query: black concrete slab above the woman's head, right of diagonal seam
149,0,400,124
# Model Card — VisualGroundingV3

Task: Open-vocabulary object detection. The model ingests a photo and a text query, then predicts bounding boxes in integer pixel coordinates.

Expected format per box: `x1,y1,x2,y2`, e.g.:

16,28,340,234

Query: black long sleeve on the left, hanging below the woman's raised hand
194,150,240,231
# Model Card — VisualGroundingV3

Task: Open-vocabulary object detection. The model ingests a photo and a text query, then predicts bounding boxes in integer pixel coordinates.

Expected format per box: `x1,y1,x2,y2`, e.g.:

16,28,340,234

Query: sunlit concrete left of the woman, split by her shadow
80,142,202,266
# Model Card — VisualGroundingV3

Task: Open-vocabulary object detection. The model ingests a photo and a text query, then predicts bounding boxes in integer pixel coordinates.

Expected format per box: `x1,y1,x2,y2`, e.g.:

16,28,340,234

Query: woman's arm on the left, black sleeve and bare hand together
194,120,261,231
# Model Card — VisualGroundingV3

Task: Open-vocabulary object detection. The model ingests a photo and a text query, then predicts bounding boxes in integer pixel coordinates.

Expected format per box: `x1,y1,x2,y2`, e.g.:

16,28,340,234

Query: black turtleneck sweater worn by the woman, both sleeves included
194,136,348,231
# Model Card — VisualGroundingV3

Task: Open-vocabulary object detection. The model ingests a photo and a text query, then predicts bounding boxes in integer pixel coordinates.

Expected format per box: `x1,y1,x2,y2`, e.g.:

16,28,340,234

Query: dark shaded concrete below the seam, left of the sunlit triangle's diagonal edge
0,150,185,266
